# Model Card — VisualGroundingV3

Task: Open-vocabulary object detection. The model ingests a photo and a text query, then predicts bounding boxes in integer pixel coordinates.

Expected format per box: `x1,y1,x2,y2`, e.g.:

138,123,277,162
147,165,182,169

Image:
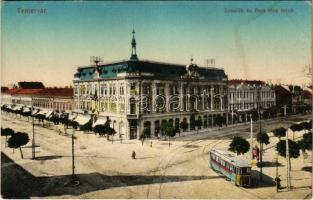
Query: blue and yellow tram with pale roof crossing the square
209,150,251,187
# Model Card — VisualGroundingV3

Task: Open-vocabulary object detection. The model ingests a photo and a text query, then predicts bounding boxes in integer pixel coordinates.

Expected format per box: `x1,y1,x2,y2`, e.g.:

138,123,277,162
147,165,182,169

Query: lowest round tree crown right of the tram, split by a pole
276,139,300,158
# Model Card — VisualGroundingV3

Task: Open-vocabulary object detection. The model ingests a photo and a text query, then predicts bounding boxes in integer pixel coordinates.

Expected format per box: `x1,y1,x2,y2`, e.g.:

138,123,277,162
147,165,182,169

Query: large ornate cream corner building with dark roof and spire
73,29,228,139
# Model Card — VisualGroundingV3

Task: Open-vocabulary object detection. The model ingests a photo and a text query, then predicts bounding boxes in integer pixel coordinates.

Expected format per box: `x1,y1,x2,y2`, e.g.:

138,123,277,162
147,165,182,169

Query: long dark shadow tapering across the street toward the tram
1,153,222,199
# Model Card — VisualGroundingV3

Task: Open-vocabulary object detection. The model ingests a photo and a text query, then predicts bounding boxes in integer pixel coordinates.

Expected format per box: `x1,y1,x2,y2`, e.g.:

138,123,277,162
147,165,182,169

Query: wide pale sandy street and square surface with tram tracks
1,112,312,199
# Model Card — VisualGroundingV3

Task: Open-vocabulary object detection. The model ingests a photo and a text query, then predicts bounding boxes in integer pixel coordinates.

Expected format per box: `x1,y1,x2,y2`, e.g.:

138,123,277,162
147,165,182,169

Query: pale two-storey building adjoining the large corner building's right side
228,79,276,122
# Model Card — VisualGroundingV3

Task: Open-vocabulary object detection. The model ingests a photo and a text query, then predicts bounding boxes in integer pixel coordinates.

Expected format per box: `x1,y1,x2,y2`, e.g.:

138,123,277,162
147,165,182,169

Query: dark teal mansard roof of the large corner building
74,60,227,81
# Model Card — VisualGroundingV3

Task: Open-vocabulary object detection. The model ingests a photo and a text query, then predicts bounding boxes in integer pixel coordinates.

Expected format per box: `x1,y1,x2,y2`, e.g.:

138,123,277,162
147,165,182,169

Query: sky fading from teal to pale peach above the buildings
1,1,312,86
